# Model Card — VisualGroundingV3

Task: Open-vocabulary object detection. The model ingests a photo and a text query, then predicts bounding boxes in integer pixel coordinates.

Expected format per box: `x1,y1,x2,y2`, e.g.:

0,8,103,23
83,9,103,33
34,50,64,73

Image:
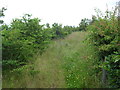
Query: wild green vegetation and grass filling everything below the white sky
0,2,120,88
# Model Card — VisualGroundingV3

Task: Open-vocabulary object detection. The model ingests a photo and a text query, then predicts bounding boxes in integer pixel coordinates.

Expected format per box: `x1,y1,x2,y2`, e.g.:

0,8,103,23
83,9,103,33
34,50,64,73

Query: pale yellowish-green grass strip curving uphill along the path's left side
32,32,86,87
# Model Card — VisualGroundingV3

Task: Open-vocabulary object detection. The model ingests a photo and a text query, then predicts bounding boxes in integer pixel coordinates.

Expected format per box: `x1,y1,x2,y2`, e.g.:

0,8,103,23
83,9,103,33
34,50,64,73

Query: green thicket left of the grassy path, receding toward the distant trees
0,14,75,71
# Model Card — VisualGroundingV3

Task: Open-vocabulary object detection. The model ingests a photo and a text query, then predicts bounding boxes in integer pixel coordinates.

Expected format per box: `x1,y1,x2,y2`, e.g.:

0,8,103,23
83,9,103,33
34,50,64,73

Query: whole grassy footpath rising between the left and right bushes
3,32,100,88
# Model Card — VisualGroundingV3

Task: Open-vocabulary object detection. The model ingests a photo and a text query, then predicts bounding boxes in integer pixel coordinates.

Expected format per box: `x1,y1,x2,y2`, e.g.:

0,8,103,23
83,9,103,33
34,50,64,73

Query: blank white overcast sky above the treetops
0,0,119,26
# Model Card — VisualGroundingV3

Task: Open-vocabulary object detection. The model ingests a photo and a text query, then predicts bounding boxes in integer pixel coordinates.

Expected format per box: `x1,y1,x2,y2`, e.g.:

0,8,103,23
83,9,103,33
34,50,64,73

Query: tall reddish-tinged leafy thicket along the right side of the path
87,8,120,88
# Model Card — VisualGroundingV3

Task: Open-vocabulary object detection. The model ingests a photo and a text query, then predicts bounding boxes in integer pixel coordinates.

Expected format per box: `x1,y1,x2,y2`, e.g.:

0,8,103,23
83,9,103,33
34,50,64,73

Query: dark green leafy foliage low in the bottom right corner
104,52,120,88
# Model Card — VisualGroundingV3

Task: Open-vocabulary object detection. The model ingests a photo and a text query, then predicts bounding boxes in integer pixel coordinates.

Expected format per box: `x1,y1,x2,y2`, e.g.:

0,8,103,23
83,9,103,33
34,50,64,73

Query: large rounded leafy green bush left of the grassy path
1,14,50,70
